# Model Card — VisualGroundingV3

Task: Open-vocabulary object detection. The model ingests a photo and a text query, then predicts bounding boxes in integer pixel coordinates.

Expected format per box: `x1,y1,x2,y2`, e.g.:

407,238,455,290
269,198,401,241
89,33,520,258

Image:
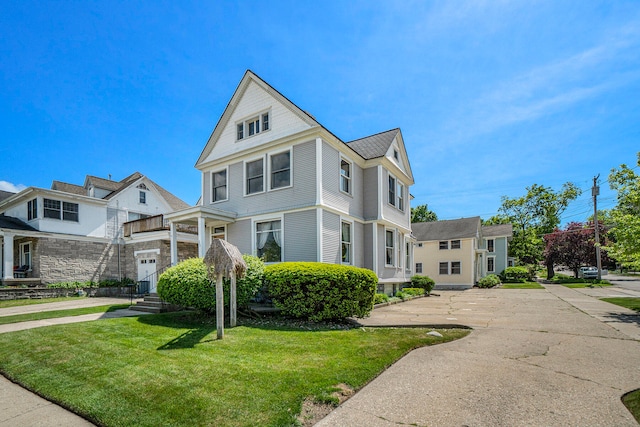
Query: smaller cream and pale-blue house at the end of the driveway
411,216,512,289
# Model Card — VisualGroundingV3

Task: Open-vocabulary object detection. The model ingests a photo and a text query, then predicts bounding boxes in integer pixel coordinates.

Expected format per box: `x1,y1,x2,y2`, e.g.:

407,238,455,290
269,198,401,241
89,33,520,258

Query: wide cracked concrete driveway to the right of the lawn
317,285,640,427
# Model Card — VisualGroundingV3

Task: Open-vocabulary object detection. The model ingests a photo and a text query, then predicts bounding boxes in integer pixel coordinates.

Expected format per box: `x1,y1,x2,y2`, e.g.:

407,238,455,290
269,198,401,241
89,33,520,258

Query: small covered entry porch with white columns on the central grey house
164,206,237,265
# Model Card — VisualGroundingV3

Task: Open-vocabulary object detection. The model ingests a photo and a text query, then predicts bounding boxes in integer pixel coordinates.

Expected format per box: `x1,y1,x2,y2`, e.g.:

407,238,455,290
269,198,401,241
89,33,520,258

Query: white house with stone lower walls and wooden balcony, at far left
0,172,196,285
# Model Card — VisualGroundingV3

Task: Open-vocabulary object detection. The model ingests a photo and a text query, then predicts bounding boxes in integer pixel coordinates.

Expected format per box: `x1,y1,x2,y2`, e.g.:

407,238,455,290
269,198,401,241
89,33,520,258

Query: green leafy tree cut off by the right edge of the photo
605,152,640,270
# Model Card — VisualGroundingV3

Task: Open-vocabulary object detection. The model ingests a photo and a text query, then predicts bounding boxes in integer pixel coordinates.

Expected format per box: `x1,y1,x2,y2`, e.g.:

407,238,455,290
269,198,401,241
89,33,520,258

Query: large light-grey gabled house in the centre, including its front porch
166,71,414,292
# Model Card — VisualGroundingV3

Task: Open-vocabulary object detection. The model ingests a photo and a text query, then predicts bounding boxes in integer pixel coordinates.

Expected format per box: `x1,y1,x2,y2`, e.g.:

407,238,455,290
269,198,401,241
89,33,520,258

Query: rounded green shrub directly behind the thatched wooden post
158,255,264,313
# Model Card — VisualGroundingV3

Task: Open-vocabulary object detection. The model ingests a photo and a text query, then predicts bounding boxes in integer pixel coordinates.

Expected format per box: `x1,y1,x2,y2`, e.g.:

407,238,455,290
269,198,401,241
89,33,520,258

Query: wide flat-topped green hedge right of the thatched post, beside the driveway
265,262,378,322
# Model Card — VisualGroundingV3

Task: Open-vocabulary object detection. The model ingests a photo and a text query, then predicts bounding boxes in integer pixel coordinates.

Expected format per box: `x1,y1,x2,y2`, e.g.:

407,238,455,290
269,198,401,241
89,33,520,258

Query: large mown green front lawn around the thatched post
0,312,469,426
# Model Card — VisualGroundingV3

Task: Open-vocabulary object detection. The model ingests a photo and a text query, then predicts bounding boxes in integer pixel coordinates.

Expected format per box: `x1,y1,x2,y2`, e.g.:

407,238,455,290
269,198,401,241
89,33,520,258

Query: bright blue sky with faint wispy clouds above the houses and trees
0,0,640,221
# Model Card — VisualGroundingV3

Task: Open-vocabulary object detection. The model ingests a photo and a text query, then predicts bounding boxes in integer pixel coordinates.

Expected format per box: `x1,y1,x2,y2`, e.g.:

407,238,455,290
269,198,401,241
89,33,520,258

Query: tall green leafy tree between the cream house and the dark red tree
495,182,581,264
